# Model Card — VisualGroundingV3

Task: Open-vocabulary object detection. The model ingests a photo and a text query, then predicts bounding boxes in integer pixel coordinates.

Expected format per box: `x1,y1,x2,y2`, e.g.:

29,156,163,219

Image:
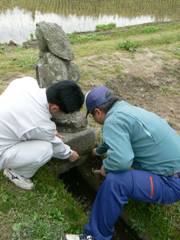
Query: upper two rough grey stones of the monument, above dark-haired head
36,22,80,87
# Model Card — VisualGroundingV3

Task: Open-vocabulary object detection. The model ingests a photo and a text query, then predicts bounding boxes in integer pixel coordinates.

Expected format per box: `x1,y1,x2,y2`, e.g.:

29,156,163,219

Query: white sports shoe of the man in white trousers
3,169,34,190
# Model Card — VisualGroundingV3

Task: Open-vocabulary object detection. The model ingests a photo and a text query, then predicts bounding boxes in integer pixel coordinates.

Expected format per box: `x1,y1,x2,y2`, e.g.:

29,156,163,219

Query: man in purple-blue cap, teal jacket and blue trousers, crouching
66,86,180,240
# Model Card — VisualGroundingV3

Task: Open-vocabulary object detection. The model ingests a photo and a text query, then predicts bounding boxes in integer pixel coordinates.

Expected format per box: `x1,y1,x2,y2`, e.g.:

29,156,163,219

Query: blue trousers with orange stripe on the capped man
85,170,180,240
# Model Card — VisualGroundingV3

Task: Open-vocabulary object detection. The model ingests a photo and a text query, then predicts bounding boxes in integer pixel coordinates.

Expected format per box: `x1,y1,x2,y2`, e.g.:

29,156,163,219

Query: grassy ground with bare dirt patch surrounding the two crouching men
0,22,180,240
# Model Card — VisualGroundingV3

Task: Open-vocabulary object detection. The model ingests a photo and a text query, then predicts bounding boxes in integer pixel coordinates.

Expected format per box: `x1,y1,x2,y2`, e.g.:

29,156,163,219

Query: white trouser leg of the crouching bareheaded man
0,140,62,178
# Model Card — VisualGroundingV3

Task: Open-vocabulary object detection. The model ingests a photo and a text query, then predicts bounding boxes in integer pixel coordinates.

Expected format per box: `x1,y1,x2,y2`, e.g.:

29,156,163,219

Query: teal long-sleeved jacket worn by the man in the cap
96,101,180,176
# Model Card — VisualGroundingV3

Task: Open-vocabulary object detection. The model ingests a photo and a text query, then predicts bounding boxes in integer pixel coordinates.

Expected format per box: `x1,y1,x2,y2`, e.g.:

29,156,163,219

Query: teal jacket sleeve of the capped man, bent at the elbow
103,116,134,172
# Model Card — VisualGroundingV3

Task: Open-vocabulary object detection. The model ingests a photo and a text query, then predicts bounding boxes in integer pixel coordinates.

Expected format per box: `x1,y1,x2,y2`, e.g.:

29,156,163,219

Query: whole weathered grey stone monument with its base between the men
36,22,95,173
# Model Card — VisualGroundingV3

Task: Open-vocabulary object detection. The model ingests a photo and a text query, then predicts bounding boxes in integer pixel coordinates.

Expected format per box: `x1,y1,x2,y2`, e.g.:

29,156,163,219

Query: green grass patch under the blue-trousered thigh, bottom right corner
126,201,180,240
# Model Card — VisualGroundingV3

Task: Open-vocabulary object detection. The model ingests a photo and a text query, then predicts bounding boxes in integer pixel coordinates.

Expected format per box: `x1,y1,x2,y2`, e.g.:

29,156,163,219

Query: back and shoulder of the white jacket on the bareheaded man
0,77,53,158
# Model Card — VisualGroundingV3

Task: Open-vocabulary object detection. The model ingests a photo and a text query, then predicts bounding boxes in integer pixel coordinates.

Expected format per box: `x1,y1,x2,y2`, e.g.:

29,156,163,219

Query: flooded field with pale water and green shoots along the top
0,0,180,44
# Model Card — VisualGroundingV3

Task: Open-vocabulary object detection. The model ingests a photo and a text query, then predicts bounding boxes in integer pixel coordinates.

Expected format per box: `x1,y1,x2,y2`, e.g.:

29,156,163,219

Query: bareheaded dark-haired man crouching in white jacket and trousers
0,77,84,190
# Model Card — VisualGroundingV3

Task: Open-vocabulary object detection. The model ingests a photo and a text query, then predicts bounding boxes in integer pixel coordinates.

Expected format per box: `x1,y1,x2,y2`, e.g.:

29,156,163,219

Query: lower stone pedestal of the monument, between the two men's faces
54,112,95,173
